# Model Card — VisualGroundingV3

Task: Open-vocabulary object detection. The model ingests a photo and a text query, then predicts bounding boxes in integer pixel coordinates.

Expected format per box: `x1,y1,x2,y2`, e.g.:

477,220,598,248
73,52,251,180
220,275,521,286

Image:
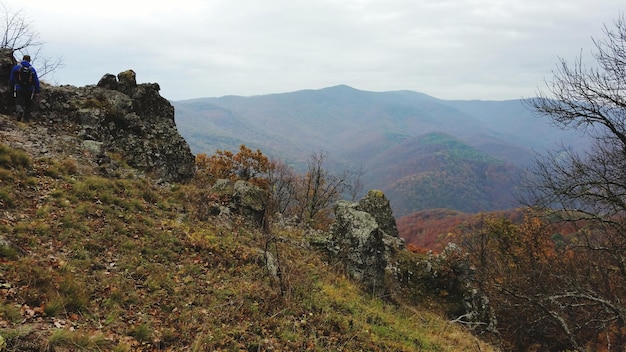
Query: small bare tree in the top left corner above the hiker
0,3,63,77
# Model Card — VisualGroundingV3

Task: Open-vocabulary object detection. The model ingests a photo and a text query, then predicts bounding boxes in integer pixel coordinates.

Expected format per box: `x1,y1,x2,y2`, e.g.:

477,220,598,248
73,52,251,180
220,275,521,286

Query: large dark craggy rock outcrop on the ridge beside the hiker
34,70,195,182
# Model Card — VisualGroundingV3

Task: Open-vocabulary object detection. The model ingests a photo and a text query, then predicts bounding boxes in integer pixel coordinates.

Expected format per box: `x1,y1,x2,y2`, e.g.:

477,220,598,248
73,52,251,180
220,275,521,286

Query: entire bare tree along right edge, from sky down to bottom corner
516,14,626,350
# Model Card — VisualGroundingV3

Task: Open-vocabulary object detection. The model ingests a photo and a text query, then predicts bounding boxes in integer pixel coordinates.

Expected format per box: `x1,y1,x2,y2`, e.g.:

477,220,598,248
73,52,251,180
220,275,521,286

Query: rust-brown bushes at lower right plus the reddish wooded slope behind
398,209,626,351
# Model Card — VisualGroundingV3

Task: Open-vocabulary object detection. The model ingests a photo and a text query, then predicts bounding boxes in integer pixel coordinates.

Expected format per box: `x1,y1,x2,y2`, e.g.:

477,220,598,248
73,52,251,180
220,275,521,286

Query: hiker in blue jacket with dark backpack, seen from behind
10,55,41,122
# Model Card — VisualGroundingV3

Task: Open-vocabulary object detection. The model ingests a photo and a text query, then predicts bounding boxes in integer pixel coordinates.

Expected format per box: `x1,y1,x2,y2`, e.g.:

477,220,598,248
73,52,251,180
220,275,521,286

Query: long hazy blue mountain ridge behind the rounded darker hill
172,85,584,214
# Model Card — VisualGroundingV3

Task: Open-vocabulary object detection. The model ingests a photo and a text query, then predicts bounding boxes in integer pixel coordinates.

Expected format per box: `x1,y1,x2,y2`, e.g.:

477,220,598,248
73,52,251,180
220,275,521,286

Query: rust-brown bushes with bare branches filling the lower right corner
454,212,626,351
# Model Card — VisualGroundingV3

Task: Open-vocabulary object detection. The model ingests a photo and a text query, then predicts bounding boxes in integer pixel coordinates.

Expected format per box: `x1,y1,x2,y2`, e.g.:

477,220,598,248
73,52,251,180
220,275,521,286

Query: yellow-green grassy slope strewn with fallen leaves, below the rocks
0,121,491,351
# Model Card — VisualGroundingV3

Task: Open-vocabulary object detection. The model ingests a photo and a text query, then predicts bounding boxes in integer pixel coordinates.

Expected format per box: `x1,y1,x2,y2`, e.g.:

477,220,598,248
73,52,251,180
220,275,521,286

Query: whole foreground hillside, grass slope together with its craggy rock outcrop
0,66,495,351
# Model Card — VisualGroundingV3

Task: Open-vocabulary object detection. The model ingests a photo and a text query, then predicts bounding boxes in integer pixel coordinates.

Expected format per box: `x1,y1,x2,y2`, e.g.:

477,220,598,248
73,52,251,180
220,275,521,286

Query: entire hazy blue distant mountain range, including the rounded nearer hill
172,85,585,216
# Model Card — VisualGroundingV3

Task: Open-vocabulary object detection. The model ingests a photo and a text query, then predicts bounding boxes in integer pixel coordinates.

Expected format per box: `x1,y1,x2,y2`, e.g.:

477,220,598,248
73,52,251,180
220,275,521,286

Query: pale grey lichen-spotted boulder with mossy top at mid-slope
330,190,404,294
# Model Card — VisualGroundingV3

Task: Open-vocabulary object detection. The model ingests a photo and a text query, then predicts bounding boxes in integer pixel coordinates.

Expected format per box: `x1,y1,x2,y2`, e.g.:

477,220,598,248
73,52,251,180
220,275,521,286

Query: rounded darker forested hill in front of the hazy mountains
364,132,521,216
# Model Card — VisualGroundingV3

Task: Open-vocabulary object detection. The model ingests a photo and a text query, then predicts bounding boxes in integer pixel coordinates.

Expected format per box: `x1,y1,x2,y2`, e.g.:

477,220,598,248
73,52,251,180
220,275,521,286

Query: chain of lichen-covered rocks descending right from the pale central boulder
330,190,497,334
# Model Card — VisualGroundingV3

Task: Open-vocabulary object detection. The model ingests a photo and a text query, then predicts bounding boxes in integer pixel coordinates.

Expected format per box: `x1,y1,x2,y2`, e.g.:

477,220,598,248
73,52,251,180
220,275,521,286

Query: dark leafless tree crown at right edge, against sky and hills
526,15,626,270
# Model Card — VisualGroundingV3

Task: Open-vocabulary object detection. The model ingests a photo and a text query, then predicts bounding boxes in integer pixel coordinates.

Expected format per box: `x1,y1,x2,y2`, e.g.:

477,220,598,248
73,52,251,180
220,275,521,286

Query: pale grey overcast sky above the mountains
0,0,626,100
